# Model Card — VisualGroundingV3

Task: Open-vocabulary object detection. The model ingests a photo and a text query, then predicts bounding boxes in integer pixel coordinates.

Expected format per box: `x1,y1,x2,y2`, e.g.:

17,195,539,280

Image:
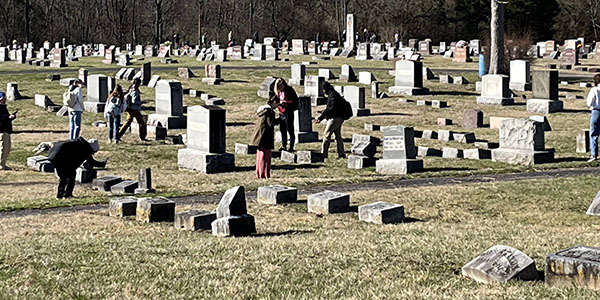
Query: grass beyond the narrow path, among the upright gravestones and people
0,56,598,211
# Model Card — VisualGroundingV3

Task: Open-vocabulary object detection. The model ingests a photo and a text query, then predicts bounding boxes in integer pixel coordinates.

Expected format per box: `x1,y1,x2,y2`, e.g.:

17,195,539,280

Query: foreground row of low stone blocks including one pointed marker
109,185,404,237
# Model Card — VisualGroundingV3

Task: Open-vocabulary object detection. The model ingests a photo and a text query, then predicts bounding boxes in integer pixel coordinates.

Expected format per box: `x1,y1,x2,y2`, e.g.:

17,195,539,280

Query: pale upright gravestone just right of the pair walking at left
148,80,186,130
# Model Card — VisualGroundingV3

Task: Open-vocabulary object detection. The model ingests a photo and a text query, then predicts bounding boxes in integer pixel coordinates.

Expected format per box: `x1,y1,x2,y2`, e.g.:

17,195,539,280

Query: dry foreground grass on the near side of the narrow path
0,177,600,300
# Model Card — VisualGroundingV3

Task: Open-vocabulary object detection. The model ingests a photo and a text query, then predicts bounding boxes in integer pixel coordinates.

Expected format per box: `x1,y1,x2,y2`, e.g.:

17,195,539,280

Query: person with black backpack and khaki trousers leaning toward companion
315,81,352,158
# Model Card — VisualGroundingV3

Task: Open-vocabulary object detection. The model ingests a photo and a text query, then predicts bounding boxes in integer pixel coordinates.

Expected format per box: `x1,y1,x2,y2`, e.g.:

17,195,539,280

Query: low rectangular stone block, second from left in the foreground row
135,197,175,223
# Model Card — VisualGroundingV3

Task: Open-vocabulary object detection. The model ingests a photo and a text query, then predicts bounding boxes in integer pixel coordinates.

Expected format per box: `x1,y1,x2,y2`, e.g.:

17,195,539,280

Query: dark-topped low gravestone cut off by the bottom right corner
544,246,600,290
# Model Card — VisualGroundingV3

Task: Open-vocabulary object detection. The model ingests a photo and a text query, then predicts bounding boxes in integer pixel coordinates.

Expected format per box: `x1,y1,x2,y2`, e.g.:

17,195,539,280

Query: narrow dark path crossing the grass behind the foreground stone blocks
0,167,600,218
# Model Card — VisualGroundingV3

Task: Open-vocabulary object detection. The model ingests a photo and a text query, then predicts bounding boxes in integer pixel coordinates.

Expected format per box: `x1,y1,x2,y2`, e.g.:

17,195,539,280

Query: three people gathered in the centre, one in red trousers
250,78,352,179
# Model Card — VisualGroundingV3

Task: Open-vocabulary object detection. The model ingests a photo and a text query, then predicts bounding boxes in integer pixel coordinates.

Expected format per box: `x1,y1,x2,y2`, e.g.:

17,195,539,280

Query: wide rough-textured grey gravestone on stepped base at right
492,119,554,166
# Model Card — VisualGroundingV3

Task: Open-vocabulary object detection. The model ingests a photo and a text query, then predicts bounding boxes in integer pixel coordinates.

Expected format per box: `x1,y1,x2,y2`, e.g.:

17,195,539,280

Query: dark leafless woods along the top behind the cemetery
0,0,600,46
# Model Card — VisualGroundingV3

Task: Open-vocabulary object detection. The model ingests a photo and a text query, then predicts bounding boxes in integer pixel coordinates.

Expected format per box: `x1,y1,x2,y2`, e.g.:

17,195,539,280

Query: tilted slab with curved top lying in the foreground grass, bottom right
461,245,537,283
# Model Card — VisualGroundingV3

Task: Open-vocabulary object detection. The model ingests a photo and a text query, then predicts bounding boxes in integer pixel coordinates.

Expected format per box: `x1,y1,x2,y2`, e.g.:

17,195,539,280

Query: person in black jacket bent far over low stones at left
48,137,108,199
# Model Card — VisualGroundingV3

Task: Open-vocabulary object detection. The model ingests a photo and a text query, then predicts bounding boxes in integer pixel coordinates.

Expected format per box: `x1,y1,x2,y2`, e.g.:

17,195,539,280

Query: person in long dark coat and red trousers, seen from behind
250,100,280,179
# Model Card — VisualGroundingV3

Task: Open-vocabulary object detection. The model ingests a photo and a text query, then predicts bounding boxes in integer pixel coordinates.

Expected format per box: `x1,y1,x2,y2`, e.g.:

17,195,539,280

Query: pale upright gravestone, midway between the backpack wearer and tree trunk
389,60,429,96
